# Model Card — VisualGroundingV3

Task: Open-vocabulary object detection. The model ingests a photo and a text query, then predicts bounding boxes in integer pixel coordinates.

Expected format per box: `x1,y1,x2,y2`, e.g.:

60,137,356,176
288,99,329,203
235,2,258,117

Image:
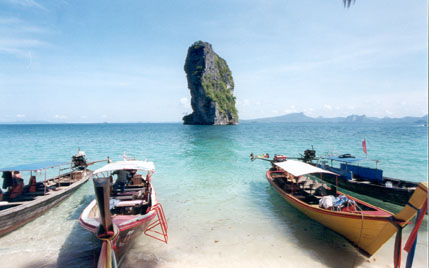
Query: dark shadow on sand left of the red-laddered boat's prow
56,195,100,268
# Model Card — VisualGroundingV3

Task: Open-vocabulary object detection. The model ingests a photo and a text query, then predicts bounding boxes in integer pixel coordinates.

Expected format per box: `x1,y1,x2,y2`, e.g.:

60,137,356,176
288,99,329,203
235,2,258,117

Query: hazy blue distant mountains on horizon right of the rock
240,113,428,125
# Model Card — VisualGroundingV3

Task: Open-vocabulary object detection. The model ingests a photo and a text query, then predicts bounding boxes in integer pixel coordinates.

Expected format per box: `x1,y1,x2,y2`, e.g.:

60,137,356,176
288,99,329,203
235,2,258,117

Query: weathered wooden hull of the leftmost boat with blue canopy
0,171,91,237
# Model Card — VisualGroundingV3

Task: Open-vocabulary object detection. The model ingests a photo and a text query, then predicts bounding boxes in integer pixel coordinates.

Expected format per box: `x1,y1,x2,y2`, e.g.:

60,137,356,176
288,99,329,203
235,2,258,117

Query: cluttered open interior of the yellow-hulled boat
271,171,377,213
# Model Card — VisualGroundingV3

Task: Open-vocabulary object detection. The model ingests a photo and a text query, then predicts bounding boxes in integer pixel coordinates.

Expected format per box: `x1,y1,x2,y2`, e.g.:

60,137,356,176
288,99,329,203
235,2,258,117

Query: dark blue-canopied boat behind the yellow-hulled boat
316,154,418,206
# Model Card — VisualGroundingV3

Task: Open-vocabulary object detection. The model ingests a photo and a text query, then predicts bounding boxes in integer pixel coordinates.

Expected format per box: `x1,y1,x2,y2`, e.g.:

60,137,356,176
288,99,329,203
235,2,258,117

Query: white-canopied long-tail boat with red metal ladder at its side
79,160,168,268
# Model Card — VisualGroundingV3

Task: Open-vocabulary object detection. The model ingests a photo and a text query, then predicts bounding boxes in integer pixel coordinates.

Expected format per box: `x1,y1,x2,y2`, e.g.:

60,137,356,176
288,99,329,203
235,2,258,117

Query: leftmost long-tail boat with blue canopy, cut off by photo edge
0,152,97,237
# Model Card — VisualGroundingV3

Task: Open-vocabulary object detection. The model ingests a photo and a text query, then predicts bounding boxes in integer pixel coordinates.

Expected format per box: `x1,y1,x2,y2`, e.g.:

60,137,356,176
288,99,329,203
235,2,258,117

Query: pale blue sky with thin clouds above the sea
0,0,428,122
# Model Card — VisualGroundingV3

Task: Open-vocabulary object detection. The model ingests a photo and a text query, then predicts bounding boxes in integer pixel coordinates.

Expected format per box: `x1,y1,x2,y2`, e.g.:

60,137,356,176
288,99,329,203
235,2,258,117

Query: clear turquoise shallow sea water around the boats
0,123,428,267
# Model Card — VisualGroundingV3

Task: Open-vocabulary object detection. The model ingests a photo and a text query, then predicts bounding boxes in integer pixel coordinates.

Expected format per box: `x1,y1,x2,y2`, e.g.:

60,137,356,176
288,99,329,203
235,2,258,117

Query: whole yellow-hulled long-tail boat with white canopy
266,160,428,256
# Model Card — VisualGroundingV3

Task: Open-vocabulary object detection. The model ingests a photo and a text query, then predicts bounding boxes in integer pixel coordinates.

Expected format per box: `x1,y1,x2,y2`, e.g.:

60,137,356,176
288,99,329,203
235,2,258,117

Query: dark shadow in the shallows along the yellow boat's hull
250,181,369,267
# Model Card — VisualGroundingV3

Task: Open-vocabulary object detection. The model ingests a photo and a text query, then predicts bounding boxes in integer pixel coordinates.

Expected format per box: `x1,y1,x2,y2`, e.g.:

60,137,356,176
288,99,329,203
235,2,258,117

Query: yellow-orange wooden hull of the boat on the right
266,170,427,256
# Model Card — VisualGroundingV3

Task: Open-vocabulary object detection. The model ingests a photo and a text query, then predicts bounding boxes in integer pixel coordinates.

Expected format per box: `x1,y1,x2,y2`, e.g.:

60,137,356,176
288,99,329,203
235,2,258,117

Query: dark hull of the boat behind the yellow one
312,169,417,206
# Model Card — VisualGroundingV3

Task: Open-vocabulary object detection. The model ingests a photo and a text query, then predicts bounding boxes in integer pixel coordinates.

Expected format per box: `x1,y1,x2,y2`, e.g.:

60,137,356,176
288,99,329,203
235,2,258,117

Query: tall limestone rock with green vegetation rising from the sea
183,41,238,125
